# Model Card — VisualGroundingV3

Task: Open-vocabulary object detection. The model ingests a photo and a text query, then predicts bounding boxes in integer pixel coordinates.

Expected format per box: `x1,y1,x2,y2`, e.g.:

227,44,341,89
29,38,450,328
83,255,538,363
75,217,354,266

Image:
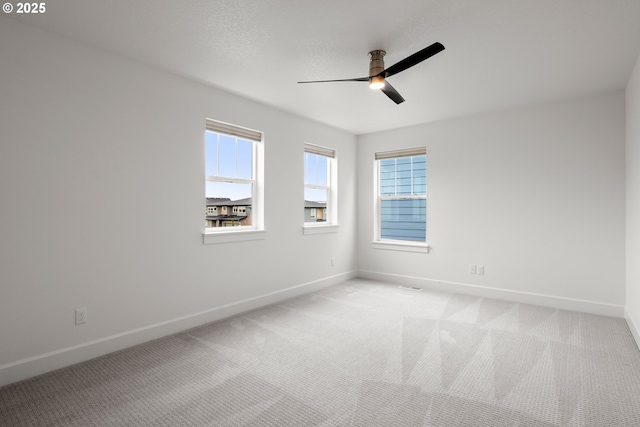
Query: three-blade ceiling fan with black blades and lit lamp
298,42,444,104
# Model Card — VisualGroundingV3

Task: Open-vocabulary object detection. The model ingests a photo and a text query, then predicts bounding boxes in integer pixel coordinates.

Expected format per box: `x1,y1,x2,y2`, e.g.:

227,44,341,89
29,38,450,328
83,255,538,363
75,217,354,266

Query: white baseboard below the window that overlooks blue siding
358,270,624,318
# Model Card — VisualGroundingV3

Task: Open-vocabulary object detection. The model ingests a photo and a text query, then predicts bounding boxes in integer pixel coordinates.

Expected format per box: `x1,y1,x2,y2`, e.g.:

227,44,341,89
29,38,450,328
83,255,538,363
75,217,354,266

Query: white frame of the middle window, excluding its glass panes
302,142,338,235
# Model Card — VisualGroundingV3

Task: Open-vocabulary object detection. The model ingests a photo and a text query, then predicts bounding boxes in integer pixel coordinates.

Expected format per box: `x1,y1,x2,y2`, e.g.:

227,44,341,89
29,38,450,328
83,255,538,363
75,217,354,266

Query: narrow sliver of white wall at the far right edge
625,54,640,346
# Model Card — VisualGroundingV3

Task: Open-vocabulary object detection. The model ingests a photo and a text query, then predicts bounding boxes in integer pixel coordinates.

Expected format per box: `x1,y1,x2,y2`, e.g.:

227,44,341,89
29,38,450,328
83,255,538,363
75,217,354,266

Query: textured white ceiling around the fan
11,0,640,134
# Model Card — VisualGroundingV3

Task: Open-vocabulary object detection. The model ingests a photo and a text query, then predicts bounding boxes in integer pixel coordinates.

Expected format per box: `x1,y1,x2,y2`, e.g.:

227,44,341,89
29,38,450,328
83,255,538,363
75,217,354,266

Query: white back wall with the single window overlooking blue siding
358,92,625,316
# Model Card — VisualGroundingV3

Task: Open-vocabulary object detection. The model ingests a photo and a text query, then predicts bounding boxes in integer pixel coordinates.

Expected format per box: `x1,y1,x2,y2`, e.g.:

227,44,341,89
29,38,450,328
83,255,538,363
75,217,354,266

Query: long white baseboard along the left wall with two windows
0,271,357,387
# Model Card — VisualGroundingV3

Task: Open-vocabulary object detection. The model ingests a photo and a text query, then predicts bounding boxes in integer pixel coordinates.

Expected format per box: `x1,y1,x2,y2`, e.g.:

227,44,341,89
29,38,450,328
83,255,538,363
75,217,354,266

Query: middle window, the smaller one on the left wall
304,143,337,234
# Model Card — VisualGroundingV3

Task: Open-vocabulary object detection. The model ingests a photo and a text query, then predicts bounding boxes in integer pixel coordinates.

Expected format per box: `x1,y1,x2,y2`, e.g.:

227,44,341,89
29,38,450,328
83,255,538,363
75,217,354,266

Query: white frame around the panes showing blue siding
372,146,429,253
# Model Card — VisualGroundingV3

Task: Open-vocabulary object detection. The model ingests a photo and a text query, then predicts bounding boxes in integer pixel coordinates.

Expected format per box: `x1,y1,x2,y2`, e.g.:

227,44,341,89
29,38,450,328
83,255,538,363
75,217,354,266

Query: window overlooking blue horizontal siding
375,148,427,246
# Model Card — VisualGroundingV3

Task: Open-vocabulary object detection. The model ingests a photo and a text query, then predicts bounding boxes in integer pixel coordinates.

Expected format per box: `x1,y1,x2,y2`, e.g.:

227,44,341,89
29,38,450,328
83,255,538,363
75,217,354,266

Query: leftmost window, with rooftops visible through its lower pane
205,119,263,243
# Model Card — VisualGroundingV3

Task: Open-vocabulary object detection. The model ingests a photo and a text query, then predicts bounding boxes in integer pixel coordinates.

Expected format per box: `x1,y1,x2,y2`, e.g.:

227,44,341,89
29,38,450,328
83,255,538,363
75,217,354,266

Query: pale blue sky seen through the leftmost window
205,131,253,200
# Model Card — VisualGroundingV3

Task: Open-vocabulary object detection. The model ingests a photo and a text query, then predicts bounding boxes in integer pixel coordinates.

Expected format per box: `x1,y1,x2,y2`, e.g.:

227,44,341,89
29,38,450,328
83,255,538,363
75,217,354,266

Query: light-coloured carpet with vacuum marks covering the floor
0,279,640,427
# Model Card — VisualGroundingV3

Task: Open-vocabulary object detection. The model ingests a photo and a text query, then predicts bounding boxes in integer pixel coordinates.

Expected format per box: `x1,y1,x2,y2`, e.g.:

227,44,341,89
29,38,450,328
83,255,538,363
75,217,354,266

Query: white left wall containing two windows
0,18,356,385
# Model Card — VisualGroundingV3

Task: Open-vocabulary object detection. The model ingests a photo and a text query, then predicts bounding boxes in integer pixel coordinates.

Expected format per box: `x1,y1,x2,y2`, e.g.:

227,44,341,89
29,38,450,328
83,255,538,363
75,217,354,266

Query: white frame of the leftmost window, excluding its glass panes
203,118,266,244
